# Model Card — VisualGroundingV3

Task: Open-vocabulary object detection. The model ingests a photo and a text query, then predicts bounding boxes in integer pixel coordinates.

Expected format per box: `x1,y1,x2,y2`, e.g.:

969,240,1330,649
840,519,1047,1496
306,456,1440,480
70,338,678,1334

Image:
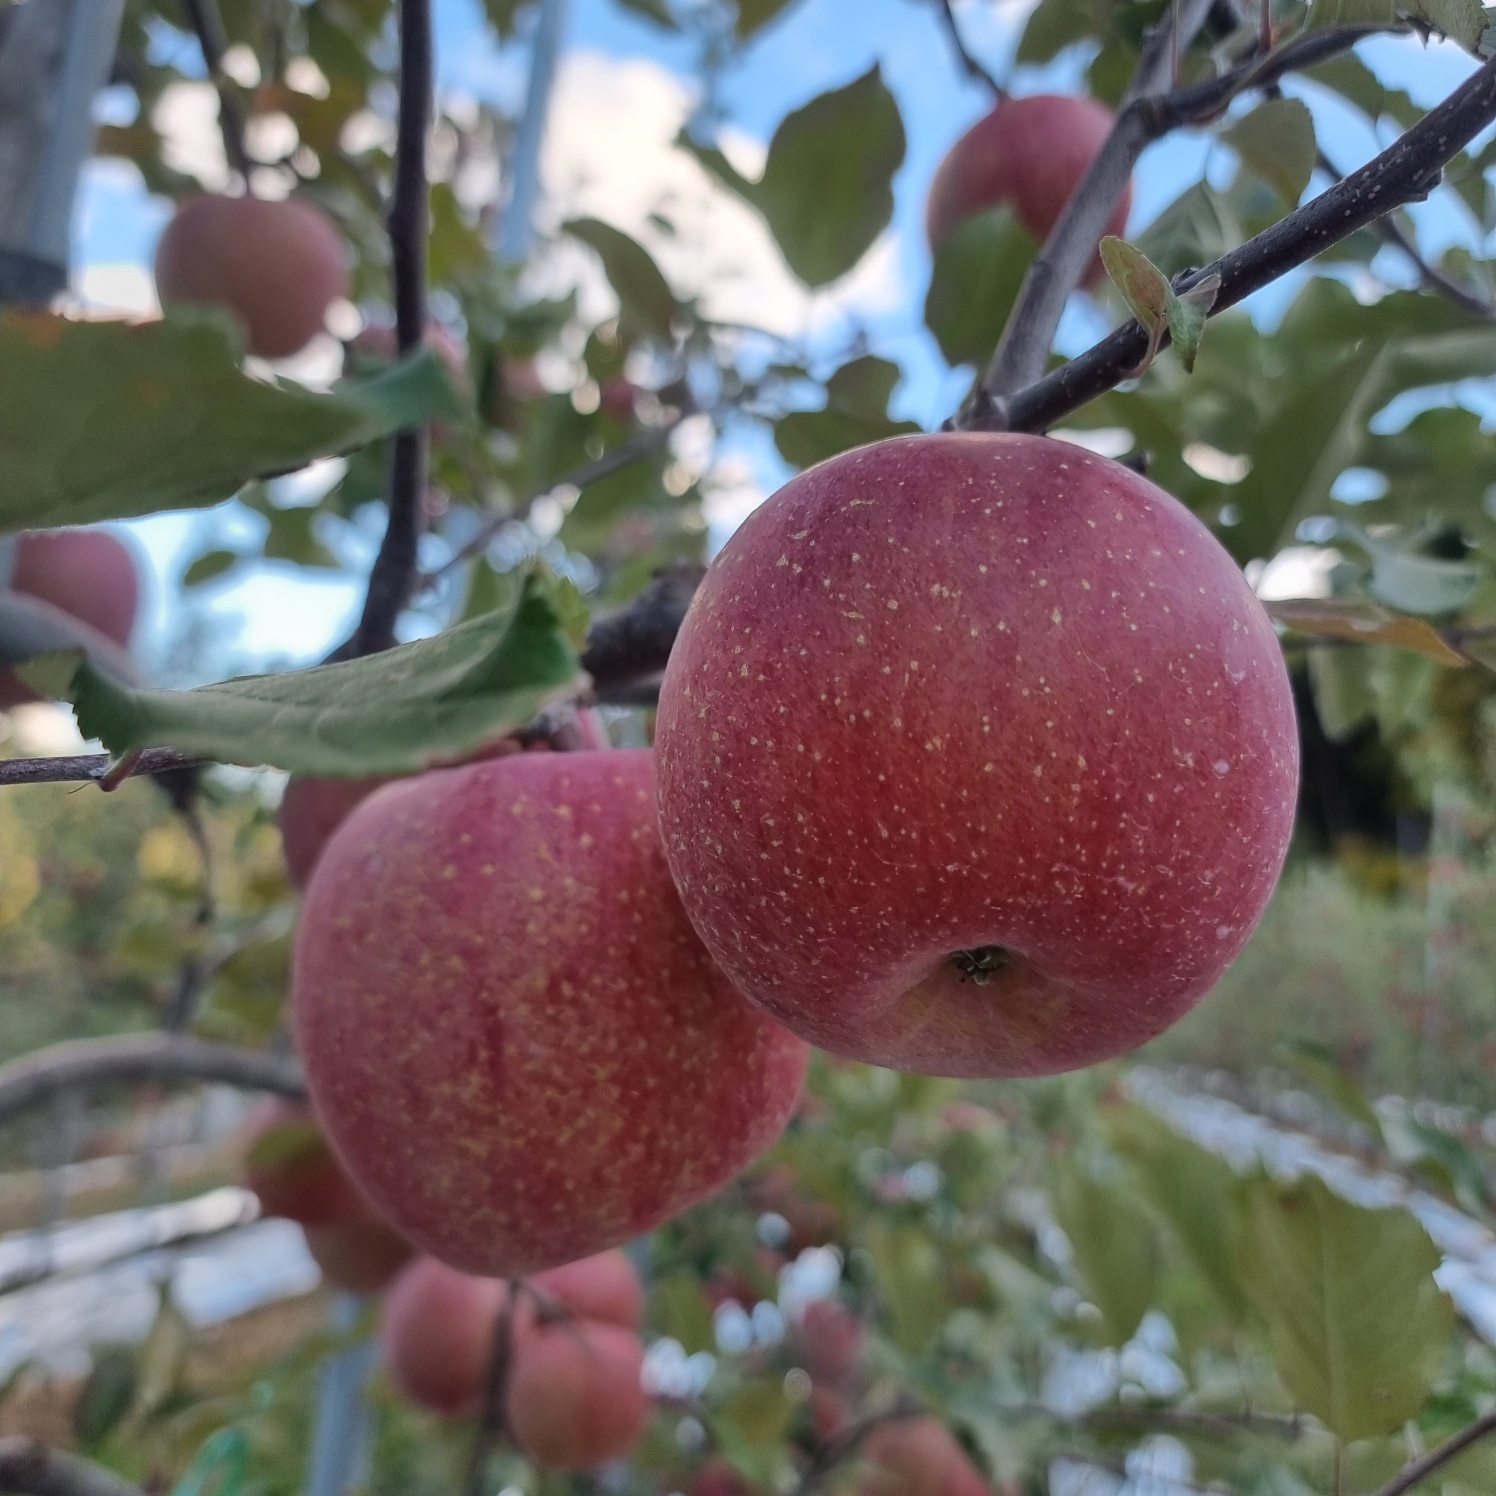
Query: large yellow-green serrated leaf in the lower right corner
1242,1177,1453,1441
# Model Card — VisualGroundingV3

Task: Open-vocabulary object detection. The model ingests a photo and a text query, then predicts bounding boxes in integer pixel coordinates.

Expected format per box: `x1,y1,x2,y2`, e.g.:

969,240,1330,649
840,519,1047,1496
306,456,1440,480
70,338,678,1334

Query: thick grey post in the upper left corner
0,0,124,305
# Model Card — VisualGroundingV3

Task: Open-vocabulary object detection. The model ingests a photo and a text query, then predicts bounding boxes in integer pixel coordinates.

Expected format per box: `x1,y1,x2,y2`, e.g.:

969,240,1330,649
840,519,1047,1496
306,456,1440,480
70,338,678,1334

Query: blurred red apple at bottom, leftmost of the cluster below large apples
380,1257,509,1418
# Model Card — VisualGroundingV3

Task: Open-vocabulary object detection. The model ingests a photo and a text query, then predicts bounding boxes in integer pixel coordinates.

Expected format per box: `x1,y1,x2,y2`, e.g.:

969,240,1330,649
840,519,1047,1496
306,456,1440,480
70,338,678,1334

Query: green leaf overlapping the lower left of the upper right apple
925,208,1038,368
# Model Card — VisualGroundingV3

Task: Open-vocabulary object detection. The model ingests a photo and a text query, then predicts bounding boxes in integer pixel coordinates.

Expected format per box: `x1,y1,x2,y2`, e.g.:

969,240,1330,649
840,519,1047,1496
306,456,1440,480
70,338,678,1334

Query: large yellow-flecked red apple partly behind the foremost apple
292,749,806,1278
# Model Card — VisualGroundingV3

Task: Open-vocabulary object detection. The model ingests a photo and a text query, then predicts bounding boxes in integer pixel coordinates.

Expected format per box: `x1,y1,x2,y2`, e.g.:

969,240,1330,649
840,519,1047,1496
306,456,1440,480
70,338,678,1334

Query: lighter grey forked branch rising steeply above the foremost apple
957,23,1403,409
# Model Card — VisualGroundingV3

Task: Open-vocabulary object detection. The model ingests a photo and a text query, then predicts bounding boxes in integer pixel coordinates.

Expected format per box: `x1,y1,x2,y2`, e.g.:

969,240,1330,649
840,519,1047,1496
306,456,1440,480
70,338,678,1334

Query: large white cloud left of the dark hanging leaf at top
540,51,908,337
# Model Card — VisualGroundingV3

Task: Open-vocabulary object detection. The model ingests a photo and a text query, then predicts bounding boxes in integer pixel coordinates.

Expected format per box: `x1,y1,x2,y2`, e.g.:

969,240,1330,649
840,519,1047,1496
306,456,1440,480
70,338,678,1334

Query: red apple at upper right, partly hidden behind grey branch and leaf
925,94,1132,280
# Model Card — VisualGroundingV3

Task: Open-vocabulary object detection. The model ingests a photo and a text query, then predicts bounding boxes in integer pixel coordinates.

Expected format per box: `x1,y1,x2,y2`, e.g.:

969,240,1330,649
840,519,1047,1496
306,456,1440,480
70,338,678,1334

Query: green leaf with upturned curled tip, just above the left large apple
43,576,577,778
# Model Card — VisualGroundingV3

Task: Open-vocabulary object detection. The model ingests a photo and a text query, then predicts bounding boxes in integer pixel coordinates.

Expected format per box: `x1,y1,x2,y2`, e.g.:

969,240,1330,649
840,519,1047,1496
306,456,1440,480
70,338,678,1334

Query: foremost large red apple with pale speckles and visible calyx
657,434,1299,1076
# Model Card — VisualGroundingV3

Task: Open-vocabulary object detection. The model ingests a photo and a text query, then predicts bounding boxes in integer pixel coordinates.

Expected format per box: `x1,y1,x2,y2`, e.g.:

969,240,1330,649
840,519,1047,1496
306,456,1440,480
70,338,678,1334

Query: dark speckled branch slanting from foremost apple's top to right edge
963,60,1496,431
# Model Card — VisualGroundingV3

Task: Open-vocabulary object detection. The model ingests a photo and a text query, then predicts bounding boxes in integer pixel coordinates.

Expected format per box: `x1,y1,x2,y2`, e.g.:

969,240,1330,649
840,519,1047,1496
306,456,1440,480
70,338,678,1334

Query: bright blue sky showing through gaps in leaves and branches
64,0,1474,679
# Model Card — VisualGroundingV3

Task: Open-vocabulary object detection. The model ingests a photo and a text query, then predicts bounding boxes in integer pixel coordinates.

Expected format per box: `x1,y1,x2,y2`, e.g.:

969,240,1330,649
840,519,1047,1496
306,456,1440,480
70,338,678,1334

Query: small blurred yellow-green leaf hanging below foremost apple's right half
1050,1164,1158,1345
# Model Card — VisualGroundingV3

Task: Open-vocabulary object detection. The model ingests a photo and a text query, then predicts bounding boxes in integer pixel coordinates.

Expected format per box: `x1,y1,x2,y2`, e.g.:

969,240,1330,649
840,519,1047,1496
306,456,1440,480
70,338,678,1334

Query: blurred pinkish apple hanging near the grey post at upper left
156,197,349,359
